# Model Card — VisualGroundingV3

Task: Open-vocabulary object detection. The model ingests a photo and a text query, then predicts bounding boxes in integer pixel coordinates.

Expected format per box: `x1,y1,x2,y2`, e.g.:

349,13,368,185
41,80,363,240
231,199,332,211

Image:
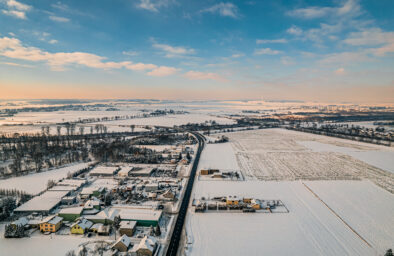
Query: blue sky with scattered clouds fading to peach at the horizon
0,0,394,103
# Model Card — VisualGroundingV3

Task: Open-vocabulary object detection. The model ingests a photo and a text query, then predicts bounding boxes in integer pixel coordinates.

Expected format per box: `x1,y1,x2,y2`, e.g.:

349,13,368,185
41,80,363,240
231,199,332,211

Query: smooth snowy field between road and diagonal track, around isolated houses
185,181,376,255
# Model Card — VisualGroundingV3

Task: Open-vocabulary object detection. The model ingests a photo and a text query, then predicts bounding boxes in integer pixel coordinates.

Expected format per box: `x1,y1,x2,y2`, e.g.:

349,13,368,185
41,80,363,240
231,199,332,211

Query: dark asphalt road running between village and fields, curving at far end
166,132,205,256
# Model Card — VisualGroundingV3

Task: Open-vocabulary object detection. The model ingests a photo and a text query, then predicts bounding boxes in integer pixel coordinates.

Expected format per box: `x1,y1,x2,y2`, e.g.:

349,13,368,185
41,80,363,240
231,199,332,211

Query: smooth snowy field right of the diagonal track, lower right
305,181,394,255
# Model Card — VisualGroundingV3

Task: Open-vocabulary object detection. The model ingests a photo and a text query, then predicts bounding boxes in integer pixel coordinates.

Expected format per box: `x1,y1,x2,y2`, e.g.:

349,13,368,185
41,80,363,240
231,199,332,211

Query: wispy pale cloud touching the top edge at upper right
287,0,360,19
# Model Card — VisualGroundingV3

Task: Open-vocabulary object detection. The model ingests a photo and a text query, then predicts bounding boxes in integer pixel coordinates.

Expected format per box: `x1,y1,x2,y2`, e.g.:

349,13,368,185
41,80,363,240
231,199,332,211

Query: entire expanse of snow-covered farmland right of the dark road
185,129,394,255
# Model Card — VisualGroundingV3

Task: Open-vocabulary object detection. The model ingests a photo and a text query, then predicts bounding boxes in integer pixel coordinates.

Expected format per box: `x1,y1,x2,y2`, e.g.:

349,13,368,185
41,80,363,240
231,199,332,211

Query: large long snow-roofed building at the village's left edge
14,191,69,214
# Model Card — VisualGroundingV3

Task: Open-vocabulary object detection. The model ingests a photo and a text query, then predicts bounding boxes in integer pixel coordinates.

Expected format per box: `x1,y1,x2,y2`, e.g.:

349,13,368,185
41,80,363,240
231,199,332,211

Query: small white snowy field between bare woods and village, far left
0,163,89,195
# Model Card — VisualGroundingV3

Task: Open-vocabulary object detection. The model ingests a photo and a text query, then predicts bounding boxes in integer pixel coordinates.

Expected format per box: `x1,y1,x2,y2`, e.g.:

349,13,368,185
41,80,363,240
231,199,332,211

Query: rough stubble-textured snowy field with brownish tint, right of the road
227,129,394,192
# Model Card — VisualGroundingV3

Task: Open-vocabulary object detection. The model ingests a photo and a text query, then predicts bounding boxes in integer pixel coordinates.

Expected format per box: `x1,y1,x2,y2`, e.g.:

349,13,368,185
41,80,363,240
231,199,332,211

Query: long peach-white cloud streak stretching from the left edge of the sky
0,37,177,76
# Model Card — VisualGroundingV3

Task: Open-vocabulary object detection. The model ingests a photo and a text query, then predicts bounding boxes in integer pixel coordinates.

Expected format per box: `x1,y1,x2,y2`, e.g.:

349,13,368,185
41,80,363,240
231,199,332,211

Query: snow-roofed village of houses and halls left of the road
0,141,195,255
